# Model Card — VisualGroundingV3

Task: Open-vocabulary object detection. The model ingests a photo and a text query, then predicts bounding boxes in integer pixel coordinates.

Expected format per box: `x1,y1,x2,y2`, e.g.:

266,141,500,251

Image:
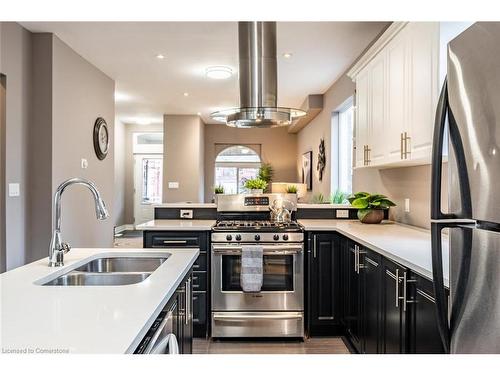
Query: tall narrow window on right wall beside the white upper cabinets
332,97,354,193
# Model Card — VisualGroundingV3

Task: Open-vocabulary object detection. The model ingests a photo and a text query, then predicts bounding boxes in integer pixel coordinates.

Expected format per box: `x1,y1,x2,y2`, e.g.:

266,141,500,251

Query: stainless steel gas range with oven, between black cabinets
211,194,304,338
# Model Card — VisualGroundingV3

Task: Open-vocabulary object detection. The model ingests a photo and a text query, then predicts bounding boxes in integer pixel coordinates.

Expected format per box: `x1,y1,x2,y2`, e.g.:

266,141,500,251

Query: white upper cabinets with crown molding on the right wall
348,22,463,167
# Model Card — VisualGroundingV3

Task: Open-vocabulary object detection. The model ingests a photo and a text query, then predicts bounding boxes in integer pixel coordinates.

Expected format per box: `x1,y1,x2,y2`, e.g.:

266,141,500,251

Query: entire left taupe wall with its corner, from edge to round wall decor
0,22,114,269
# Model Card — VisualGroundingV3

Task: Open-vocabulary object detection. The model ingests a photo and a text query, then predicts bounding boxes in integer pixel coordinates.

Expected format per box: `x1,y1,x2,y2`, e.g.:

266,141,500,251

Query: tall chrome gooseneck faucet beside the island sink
49,178,109,267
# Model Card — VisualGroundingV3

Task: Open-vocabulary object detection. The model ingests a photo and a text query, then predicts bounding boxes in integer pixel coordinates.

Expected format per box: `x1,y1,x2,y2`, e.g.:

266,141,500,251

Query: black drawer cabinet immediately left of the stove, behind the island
143,231,210,337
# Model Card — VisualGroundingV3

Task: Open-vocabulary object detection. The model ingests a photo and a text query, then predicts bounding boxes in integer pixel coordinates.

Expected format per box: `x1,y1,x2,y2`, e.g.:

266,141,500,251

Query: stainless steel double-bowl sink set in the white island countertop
42,254,171,286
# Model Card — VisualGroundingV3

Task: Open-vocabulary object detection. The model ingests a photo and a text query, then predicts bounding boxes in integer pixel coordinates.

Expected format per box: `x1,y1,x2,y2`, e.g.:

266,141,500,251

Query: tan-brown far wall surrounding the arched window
204,124,298,202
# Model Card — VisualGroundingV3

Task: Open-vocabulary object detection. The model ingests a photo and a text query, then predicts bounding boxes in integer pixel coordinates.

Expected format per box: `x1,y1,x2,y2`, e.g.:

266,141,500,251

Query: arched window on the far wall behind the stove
215,146,260,194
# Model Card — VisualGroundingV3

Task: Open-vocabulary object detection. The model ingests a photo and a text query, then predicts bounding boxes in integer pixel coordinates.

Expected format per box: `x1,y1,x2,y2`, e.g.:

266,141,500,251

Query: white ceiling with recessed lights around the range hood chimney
22,22,387,123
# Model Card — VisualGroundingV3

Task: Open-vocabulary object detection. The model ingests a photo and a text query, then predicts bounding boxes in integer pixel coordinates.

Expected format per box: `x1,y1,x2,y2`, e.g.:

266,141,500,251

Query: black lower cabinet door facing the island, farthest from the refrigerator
344,241,363,353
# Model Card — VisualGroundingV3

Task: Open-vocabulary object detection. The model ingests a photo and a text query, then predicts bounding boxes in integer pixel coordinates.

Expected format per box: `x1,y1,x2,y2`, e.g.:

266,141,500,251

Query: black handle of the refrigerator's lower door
431,223,450,353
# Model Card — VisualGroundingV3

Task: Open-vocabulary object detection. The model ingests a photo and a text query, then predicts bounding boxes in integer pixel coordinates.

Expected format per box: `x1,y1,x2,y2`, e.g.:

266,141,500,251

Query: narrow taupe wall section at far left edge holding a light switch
0,22,32,269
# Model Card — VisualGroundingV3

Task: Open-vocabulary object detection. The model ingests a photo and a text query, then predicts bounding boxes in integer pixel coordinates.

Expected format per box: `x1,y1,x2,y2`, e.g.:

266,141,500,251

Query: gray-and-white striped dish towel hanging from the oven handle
240,245,264,292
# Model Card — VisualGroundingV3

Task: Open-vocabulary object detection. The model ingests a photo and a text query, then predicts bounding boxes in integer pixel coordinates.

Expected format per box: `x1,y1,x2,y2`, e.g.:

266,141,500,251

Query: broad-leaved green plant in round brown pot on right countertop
348,191,396,224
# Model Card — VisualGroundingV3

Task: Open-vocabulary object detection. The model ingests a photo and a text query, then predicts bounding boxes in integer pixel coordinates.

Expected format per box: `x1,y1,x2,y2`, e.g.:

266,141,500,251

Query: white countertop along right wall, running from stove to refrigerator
298,219,449,286
